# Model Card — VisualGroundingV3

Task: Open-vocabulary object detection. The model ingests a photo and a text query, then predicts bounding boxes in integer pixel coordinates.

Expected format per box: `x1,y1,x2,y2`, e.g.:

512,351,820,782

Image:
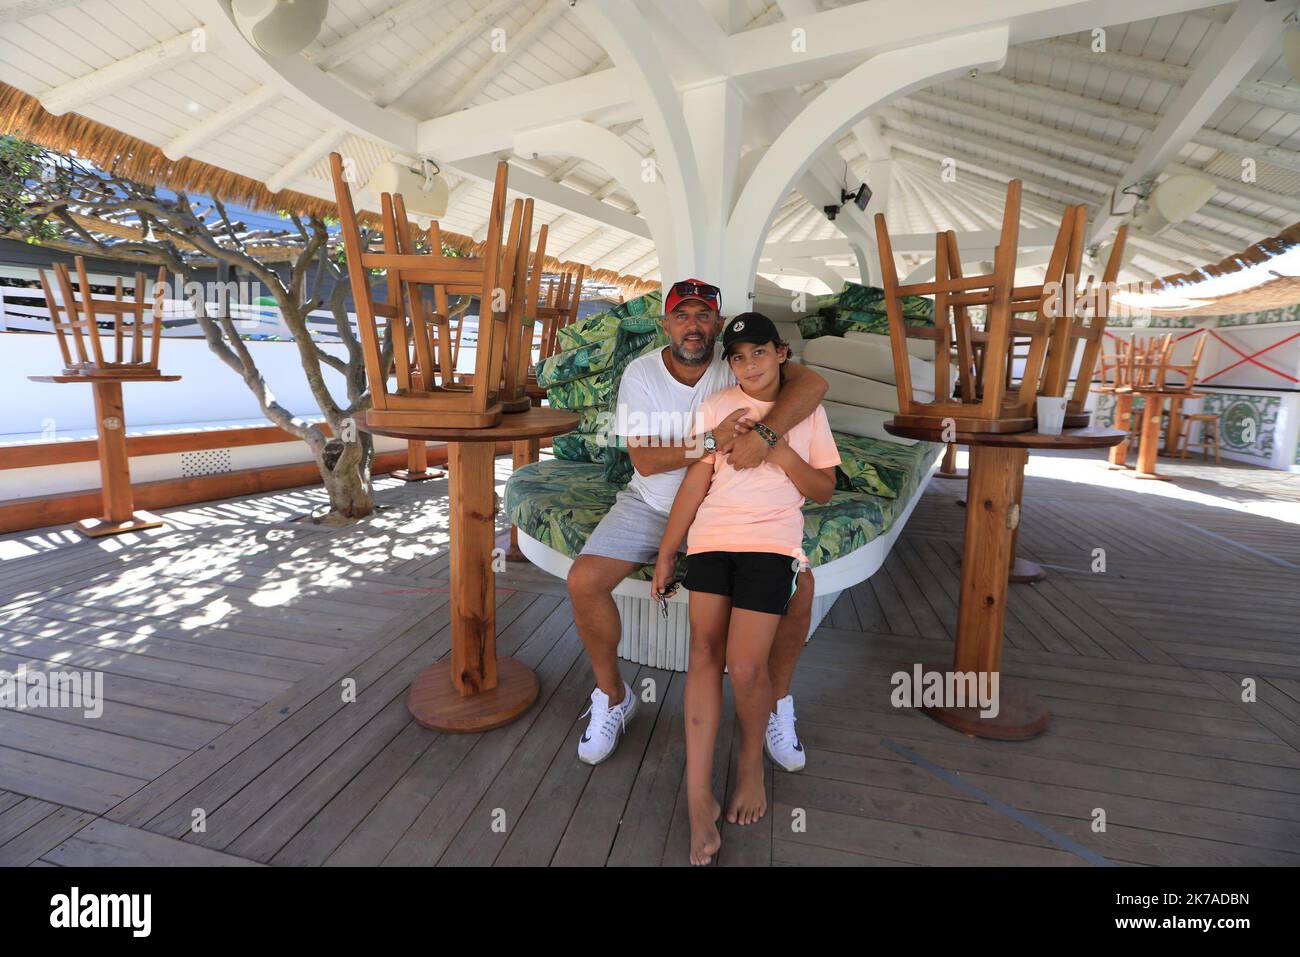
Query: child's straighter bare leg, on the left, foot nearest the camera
685,592,731,865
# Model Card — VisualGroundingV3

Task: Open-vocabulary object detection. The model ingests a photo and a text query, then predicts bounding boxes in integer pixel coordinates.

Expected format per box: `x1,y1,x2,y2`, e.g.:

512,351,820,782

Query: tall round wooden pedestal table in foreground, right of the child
885,423,1125,741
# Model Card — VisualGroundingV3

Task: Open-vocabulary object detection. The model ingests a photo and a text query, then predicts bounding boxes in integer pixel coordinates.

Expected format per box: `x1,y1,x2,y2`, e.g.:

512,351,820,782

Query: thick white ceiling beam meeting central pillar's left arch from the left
416,69,640,163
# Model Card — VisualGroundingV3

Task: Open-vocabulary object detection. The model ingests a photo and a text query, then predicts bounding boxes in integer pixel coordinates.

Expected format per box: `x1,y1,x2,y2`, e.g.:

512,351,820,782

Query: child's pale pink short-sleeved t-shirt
686,385,840,557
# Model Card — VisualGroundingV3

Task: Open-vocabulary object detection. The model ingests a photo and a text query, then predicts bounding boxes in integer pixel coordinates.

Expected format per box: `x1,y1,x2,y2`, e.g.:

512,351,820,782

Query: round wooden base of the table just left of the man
407,658,538,735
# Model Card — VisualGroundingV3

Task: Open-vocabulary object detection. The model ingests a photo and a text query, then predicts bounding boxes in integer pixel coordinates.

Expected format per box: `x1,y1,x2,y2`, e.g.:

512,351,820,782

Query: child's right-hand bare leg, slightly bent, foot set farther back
727,607,780,824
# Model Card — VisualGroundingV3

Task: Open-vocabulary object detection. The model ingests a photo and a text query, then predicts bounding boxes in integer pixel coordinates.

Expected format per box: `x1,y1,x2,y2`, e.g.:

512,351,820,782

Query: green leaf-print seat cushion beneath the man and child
506,436,941,580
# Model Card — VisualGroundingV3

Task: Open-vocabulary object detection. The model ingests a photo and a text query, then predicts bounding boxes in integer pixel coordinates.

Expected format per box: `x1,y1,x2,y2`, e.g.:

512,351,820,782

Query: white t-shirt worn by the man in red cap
614,342,736,514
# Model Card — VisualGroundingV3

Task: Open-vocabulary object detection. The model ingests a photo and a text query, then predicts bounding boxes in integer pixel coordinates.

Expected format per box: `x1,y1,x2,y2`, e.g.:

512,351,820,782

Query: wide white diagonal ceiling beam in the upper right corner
1088,3,1288,244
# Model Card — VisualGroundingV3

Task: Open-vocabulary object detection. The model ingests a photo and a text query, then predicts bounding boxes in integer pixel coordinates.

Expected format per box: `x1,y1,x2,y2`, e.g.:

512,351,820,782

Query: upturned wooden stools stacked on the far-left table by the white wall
36,256,166,378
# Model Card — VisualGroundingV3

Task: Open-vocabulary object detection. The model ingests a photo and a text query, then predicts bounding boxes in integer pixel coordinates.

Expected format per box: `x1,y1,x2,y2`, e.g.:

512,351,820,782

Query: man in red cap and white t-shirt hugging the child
568,280,827,771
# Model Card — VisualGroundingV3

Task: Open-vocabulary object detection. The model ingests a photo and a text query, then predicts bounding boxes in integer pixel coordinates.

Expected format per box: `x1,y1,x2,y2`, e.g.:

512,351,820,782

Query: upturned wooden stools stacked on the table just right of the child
875,179,1086,433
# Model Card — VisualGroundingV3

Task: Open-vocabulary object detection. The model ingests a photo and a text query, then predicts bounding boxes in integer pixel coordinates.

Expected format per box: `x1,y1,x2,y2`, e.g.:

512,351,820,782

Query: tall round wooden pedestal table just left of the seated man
356,408,577,733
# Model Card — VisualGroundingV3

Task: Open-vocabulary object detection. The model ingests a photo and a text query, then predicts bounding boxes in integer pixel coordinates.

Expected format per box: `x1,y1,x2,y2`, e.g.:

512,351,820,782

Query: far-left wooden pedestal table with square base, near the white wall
27,372,181,538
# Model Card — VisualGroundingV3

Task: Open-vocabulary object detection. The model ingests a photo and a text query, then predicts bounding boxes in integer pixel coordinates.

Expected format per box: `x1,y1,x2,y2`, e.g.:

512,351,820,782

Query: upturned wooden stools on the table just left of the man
330,153,533,428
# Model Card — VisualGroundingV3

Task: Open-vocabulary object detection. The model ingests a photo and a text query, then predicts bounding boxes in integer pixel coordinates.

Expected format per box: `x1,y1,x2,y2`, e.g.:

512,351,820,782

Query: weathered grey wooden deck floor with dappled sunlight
0,447,1300,866
